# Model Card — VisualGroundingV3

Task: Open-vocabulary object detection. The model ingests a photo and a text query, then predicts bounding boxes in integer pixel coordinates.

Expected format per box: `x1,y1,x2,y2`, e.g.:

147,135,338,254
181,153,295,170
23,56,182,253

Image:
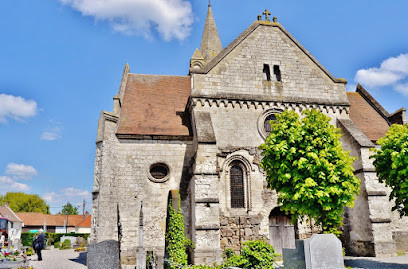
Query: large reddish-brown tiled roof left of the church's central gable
117,74,191,136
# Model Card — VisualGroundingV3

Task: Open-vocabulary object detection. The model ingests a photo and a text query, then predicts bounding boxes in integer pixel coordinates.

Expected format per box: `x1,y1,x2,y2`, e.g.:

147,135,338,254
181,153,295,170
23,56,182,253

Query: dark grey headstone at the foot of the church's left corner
88,240,120,269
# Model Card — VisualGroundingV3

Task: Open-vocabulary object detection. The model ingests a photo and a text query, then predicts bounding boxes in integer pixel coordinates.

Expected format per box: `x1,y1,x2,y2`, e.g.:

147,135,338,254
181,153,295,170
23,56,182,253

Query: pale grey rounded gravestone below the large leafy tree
304,234,344,269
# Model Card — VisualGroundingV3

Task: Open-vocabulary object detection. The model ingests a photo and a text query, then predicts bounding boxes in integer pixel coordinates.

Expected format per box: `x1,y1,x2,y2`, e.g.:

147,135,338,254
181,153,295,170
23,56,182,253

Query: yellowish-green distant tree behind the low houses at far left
0,192,50,214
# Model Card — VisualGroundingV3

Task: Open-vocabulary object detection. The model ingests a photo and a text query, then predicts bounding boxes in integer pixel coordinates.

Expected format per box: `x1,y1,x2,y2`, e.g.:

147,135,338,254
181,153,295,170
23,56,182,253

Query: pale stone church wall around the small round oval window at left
92,108,194,266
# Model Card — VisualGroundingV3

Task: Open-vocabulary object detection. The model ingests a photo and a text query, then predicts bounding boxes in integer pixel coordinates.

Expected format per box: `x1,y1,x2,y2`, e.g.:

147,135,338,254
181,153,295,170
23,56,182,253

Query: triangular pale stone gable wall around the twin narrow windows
192,26,348,104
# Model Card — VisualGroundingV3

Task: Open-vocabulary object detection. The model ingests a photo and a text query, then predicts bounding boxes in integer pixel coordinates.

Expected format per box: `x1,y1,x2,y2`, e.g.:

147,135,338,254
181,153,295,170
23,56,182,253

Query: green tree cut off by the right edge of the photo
371,124,408,217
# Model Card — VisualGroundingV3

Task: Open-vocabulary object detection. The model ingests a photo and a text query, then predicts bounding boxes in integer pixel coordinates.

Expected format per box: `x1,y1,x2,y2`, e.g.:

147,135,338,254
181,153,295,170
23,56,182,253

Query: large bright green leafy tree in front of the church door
260,109,360,235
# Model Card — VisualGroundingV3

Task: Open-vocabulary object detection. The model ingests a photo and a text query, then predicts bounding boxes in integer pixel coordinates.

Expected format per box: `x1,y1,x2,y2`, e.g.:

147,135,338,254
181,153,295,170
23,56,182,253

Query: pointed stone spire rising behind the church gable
200,1,222,62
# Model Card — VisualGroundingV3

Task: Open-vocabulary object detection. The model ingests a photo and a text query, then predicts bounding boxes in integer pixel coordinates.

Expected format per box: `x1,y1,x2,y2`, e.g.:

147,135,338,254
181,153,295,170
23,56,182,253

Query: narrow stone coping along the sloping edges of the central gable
190,21,347,84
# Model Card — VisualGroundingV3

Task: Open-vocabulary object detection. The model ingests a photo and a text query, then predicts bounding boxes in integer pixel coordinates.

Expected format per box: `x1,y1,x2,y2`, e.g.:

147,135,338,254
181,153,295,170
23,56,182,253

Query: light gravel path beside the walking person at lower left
28,249,86,269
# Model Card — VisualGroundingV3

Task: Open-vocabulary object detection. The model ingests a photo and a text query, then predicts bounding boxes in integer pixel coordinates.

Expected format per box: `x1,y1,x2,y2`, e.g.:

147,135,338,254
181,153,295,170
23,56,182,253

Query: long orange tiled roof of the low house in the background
16,212,88,226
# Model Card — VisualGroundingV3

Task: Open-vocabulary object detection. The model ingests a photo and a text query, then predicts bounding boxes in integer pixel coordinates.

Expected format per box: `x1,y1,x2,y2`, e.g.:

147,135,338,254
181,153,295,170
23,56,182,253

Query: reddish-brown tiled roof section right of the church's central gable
347,92,389,141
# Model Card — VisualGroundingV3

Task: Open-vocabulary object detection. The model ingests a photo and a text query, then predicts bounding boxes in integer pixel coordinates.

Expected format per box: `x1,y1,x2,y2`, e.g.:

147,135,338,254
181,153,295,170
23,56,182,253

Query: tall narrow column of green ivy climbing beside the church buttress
165,193,188,269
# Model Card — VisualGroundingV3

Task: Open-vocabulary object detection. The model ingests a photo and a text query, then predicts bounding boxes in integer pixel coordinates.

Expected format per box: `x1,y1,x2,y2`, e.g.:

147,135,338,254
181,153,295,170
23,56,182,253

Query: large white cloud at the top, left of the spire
60,0,193,41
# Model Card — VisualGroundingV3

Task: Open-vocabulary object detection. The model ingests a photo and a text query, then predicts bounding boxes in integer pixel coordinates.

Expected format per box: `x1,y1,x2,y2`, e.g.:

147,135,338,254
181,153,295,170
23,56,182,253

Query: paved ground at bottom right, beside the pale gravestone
344,254,408,269
